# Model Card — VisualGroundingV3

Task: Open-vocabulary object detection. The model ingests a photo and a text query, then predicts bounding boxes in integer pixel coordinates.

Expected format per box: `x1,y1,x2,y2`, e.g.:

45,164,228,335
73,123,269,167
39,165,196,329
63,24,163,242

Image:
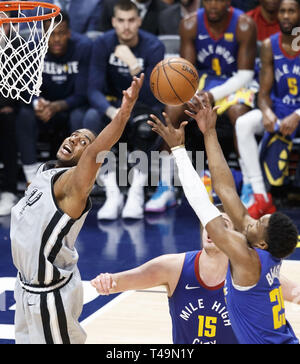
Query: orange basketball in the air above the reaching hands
150,57,199,106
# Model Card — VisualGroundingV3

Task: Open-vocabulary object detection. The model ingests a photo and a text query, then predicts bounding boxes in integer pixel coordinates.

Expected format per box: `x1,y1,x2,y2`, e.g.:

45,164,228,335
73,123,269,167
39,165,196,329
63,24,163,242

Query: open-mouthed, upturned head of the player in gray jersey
56,129,96,167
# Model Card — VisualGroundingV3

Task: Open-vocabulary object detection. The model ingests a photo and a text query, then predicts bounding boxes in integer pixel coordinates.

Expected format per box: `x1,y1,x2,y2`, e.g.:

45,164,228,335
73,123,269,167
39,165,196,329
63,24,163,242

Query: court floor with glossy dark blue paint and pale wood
0,199,300,344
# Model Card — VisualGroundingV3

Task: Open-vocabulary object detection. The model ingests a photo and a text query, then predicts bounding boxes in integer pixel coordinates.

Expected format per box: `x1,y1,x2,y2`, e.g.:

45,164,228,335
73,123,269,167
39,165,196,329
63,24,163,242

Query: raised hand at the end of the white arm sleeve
148,112,188,148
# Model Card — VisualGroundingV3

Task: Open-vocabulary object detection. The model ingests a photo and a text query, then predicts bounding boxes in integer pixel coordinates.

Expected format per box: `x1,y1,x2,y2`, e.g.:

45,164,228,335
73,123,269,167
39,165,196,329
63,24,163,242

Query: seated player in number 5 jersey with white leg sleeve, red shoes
236,0,300,219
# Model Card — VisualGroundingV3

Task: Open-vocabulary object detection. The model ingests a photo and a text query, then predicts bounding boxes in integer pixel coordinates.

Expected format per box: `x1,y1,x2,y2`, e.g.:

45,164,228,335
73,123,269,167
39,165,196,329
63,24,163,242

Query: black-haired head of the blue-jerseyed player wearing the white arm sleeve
247,212,298,259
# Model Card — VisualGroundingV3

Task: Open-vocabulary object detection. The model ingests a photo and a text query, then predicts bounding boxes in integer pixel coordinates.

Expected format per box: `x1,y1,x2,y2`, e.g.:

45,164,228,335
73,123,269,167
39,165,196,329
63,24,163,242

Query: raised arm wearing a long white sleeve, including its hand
148,113,259,286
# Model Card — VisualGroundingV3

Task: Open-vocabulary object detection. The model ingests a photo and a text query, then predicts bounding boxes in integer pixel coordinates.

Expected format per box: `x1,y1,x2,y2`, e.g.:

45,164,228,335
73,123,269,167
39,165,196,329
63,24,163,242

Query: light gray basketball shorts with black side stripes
15,270,86,344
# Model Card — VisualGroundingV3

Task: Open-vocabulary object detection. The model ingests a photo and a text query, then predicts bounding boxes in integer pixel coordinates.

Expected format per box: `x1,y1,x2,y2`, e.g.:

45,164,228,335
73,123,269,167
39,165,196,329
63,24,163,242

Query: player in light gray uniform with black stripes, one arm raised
11,74,144,344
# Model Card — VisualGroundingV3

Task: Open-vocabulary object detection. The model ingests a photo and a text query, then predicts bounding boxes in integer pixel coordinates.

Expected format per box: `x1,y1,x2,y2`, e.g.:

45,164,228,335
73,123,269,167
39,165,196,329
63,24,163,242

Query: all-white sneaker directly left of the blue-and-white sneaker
122,188,145,219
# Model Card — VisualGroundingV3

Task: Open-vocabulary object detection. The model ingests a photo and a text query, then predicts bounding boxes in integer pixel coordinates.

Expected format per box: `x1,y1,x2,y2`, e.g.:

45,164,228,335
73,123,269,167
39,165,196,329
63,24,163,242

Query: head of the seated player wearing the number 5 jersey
278,0,300,35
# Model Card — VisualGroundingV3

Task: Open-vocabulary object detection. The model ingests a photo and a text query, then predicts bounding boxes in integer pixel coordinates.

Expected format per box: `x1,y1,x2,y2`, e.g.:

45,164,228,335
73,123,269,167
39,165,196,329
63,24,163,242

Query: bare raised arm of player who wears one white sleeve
186,94,253,232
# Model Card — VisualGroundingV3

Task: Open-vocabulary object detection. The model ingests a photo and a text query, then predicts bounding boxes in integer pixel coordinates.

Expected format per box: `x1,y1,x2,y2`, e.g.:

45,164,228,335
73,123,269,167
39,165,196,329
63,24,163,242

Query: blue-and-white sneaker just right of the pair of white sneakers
145,182,177,213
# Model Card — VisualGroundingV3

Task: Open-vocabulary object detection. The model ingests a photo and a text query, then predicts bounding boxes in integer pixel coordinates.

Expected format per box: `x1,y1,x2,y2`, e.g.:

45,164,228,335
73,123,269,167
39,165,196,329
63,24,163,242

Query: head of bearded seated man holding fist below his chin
112,0,142,45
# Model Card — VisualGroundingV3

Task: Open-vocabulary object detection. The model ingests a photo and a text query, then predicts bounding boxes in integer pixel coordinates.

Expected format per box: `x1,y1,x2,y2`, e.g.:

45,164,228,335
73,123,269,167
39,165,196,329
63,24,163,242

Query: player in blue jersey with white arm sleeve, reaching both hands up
149,94,299,344
